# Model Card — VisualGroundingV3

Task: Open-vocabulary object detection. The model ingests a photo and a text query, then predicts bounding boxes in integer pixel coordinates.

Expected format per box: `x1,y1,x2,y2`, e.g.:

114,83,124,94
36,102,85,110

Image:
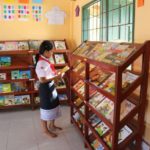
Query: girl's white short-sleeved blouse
35,56,55,79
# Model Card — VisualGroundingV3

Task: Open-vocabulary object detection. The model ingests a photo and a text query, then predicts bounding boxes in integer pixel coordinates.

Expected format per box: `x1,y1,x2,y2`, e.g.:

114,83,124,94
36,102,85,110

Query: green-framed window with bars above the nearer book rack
82,0,135,42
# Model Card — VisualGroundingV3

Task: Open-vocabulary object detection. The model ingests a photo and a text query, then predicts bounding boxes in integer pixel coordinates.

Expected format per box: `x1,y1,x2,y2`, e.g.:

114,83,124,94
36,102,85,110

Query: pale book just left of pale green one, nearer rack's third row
89,92,105,108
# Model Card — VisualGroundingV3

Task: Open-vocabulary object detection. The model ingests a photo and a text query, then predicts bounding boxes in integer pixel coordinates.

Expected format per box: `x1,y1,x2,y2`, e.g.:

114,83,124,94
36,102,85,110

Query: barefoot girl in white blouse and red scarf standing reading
35,41,62,137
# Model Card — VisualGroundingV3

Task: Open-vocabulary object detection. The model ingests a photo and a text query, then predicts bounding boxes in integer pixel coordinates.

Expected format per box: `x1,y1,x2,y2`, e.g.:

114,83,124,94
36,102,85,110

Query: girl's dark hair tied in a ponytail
35,40,53,64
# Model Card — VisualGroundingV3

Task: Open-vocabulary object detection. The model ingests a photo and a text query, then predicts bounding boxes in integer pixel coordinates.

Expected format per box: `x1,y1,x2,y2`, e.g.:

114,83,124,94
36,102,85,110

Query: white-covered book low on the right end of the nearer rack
118,125,132,144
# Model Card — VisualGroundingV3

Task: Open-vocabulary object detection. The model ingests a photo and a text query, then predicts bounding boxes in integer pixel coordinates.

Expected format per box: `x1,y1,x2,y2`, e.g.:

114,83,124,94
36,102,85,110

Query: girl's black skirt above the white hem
39,81,59,110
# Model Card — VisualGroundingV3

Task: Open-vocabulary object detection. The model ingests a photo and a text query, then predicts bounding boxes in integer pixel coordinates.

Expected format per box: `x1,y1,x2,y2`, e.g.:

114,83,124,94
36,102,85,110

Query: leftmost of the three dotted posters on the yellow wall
3,4,15,20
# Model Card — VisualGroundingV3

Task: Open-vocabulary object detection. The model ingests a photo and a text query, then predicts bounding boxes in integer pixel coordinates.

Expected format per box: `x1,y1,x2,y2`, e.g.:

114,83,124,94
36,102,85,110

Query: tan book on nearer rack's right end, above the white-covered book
120,99,135,120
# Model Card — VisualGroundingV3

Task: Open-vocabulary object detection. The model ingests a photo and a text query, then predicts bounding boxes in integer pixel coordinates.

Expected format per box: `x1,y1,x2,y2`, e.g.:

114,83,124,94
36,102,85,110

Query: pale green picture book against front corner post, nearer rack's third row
96,98,114,122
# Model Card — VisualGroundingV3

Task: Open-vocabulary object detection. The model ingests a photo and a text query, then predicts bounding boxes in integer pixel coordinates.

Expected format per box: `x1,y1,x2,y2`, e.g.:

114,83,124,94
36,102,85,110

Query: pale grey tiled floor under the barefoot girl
0,106,85,150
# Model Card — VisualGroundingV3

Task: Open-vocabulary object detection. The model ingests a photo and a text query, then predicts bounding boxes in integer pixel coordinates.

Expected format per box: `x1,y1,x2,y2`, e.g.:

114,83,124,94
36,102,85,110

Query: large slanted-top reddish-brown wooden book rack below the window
68,41,150,150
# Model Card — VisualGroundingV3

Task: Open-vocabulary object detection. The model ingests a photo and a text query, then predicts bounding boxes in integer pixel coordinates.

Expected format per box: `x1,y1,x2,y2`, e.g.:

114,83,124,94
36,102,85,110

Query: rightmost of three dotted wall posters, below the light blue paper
32,5,42,22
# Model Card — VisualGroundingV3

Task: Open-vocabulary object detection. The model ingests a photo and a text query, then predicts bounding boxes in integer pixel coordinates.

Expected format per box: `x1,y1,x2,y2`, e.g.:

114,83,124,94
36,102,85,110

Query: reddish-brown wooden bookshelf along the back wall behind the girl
0,40,68,109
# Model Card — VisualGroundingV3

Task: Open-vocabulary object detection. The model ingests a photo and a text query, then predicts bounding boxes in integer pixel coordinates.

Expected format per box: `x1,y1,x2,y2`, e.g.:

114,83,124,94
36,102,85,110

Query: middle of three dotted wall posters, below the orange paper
17,5,29,21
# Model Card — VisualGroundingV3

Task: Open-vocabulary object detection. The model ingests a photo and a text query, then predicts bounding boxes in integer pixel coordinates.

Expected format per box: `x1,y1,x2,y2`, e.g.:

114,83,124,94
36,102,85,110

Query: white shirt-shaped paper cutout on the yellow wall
45,6,66,24
